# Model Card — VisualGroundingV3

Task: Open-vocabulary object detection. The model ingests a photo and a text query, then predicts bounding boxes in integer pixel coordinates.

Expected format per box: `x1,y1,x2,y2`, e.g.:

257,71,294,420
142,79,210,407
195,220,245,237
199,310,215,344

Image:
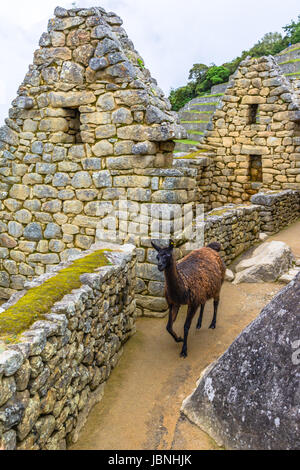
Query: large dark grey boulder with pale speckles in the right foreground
182,274,300,450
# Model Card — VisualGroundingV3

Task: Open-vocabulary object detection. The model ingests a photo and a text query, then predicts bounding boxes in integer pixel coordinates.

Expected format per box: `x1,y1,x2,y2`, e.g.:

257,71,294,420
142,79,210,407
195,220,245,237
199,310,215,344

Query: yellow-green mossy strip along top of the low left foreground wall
0,250,111,343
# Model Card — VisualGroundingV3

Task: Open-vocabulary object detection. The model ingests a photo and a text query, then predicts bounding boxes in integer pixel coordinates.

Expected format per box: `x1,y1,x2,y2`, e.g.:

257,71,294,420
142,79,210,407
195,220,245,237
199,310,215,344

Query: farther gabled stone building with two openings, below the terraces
203,56,300,208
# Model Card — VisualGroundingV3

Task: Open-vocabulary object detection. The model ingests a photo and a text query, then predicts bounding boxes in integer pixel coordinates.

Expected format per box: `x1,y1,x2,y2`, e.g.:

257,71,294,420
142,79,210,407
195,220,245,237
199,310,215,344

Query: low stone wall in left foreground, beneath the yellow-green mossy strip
0,245,136,450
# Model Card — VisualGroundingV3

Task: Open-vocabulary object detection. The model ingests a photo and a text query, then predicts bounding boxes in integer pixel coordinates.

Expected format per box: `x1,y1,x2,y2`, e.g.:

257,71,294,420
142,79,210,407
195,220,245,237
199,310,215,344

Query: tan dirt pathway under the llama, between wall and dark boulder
70,222,300,450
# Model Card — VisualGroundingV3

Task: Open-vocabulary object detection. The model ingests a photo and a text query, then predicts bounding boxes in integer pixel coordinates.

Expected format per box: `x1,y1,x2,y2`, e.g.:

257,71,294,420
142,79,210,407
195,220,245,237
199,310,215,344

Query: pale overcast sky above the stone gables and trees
0,0,300,125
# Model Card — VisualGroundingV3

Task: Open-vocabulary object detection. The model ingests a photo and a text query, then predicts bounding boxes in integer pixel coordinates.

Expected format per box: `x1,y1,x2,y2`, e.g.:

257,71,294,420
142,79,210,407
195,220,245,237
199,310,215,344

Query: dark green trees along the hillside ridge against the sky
169,15,300,111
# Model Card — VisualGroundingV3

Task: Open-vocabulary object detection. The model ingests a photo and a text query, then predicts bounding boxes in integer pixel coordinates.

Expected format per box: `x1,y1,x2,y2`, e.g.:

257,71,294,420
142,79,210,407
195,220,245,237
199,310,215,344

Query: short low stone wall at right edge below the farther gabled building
251,190,300,233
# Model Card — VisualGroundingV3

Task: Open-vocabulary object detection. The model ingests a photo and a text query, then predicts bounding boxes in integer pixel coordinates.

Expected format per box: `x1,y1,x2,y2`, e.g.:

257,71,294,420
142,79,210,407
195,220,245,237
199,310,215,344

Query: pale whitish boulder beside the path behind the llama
234,241,294,284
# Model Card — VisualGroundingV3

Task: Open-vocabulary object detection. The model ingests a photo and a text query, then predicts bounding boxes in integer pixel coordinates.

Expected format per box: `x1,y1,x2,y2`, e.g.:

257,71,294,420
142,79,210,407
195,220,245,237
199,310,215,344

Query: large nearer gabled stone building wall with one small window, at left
0,8,195,316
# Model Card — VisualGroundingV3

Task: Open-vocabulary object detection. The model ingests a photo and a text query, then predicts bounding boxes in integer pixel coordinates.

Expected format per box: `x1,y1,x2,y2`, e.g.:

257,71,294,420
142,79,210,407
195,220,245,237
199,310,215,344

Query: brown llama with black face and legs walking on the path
151,240,226,357
